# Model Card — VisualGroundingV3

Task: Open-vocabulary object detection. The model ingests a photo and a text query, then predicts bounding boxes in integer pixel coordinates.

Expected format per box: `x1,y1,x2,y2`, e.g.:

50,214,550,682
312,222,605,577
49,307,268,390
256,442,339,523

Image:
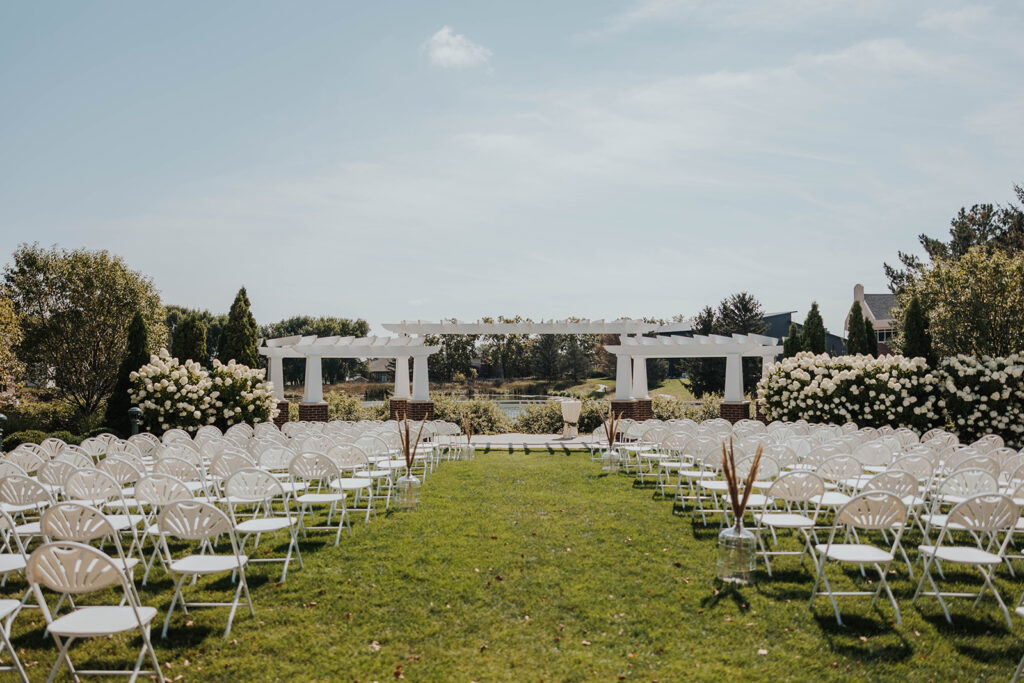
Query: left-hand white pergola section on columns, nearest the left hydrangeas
259,335,440,403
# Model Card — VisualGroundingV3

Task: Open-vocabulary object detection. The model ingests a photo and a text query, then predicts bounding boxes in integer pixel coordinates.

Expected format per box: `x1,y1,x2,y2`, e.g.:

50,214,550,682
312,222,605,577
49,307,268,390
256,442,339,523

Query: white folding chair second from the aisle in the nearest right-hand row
913,494,1020,628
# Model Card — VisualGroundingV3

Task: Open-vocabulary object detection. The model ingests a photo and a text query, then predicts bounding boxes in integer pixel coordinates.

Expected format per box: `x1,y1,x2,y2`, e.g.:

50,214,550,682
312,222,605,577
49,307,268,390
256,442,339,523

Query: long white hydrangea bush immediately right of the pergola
758,351,944,431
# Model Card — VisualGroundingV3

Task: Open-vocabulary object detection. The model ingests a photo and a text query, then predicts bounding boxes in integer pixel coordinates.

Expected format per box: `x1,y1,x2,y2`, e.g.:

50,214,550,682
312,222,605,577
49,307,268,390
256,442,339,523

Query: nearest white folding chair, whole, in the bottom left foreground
26,542,164,681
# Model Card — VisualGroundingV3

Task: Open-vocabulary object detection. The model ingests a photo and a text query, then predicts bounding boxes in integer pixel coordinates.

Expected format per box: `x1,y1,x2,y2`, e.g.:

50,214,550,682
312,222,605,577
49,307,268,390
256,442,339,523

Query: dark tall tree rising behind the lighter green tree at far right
885,185,1024,294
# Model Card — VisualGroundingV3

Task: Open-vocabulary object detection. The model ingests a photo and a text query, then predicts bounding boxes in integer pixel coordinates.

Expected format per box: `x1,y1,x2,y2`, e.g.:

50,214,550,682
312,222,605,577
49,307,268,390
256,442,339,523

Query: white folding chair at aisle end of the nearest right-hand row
810,492,907,626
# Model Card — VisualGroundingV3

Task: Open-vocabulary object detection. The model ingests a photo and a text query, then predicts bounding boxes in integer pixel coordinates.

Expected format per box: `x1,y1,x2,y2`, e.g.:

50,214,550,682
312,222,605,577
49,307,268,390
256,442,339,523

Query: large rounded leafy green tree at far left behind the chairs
3,244,164,421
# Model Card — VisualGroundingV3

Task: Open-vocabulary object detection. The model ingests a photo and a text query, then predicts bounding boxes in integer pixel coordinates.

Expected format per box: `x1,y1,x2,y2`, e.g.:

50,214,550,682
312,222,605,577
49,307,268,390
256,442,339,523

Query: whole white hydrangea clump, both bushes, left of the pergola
129,349,274,434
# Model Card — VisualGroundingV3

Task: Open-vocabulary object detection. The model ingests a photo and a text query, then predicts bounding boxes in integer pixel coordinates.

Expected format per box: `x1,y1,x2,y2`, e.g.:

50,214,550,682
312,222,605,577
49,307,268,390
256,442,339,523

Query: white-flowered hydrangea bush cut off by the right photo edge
939,353,1024,447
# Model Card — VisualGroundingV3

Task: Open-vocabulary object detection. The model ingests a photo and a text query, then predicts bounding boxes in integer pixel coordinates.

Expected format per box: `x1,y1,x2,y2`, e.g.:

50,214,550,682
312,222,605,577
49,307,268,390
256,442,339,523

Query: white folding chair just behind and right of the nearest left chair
157,501,256,638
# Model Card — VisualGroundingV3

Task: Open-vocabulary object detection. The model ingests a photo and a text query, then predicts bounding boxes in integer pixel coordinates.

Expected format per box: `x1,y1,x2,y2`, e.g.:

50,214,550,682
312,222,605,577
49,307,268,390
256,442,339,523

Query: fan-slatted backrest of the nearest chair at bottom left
25,541,131,595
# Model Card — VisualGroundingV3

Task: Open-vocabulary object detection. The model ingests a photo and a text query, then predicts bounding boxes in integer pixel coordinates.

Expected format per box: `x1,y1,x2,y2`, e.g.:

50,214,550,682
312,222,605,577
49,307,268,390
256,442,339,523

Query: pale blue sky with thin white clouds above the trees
0,0,1024,331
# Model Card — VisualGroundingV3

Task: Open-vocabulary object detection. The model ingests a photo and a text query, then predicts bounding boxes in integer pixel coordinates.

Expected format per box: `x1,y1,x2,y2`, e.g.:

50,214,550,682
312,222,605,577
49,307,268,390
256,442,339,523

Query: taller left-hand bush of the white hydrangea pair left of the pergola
129,348,216,433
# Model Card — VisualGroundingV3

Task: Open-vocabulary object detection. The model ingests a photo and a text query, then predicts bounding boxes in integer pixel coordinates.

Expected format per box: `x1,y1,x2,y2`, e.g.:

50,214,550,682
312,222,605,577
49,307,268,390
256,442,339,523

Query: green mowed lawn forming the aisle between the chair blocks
4,452,1024,681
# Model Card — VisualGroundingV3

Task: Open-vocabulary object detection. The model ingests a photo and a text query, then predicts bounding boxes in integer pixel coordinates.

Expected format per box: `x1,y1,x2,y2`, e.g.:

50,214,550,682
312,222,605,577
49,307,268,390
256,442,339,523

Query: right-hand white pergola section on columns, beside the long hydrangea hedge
604,335,782,402
